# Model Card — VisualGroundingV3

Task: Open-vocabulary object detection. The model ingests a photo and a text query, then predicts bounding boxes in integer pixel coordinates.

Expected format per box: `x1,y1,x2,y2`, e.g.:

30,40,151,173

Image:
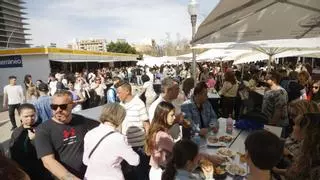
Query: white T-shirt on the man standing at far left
3,85,24,105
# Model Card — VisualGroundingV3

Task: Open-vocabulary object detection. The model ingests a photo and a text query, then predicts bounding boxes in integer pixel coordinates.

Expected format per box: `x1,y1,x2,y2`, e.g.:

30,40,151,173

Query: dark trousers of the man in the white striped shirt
121,146,150,180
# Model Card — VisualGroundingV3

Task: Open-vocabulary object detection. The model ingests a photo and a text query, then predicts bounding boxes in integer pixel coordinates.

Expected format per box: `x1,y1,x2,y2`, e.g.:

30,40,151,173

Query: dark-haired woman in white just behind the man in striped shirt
141,75,157,109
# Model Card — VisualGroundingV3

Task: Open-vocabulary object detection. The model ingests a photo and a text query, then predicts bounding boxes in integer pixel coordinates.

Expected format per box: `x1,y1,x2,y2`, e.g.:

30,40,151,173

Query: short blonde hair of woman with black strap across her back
100,103,126,127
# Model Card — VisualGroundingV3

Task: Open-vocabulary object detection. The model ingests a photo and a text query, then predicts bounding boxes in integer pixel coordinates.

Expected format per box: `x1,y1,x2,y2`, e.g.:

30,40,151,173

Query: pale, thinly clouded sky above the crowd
24,0,219,47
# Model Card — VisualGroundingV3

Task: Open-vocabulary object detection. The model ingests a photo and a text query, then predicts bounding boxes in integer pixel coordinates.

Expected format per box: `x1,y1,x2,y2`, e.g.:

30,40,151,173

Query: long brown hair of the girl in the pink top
145,101,174,155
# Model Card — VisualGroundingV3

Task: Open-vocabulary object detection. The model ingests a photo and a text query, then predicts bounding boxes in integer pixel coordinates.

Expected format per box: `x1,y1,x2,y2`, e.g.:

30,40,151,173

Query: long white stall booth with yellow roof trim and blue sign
0,47,138,95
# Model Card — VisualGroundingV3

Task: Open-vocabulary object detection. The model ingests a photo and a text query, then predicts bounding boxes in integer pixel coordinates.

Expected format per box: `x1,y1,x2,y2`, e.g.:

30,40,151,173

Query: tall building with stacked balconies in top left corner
0,0,30,48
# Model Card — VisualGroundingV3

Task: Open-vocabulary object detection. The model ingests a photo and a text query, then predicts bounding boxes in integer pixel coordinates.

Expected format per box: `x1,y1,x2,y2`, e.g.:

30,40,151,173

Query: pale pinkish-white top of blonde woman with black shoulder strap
82,124,139,180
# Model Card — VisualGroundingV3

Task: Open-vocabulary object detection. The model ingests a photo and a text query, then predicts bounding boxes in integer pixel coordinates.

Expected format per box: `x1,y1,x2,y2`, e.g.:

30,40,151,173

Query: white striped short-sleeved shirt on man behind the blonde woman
120,96,148,147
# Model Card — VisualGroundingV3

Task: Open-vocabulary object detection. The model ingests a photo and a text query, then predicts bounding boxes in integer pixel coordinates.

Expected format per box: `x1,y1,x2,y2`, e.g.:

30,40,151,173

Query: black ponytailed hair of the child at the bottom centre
161,139,199,180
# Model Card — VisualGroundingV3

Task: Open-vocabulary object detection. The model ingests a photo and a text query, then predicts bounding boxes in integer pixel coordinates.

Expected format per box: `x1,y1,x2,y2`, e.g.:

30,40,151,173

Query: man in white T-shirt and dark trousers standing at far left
3,76,25,131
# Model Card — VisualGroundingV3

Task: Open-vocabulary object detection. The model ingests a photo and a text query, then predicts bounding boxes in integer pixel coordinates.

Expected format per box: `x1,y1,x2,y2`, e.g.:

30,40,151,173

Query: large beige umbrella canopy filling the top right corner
193,0,320,44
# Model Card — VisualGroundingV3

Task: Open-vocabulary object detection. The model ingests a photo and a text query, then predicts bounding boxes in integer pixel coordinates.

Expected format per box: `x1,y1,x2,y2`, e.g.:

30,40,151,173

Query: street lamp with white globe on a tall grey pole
188,0,199,83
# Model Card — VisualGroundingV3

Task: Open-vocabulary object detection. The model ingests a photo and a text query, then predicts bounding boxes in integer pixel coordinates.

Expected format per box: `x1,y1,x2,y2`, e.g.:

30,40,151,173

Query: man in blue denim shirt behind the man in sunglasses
33,83,52,123
